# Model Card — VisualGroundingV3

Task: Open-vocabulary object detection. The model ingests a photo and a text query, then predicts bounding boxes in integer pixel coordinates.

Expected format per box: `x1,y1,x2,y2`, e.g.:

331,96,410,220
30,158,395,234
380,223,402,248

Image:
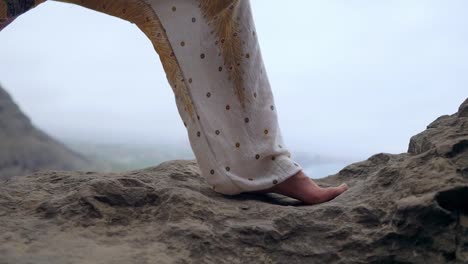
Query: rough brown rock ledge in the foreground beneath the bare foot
0,98,468,264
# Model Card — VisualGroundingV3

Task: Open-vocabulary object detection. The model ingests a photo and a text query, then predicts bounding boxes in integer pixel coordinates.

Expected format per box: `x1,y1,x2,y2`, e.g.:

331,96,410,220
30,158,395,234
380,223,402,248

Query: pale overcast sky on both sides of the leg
0,0,468,163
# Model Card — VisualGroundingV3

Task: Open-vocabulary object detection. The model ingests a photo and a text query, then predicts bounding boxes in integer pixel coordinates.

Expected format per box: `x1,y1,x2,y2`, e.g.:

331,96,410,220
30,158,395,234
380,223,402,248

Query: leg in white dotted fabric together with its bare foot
145,0,347,204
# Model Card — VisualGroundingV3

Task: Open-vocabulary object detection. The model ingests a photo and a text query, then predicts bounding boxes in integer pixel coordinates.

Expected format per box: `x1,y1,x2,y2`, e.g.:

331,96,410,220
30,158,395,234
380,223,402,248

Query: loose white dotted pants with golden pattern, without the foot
0,0,302,195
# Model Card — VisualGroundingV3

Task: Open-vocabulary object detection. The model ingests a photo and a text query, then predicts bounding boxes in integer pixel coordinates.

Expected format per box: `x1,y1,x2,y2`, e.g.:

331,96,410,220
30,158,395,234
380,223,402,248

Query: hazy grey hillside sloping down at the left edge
0,86,92,179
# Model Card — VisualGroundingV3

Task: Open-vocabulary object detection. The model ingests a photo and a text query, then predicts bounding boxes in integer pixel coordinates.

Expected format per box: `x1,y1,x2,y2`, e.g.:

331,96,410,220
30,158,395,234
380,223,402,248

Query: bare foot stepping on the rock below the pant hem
245,171,348,205
